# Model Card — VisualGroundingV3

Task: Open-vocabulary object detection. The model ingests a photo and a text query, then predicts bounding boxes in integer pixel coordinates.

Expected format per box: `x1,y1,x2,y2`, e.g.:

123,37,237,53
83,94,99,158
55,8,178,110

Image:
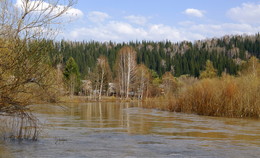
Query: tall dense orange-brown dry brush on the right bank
169,75,260,118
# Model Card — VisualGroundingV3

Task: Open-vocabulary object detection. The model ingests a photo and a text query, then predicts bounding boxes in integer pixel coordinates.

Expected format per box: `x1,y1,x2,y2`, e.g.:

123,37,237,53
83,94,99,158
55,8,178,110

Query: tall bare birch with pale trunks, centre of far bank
116,46,136,98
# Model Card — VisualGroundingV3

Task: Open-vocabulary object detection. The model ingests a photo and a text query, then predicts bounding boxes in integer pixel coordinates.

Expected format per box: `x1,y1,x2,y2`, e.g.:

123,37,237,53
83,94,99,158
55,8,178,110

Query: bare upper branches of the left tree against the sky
0,0,76,40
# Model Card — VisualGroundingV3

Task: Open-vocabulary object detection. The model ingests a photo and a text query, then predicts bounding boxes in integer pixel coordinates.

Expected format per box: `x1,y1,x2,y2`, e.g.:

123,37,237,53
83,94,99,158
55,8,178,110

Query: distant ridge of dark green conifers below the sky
47,33,260,78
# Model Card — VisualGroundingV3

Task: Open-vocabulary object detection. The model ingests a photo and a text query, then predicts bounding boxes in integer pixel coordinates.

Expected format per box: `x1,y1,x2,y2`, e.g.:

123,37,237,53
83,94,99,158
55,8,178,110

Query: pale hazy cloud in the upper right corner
227,3,260,24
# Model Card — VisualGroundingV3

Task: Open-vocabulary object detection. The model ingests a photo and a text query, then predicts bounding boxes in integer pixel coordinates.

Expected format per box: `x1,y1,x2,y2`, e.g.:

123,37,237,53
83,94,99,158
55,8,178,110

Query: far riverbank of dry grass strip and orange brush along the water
60,75,260,118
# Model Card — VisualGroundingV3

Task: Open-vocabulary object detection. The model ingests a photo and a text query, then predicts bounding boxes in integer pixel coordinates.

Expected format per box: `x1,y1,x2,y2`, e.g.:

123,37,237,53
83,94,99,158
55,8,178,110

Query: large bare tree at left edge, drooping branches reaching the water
0,0,75,139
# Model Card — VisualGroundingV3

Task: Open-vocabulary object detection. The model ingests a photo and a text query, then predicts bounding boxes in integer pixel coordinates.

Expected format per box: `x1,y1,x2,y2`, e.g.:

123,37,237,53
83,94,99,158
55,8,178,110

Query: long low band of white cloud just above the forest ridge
65,18,260,42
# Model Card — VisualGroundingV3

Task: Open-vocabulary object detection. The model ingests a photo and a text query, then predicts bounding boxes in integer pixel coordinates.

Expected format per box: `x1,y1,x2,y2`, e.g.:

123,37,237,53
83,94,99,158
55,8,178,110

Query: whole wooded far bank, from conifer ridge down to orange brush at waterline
43,33,260,117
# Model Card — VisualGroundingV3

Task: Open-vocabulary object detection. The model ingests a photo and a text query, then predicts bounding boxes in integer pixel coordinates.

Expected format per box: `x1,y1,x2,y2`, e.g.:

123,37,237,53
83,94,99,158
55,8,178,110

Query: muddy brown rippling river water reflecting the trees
0,103,260,158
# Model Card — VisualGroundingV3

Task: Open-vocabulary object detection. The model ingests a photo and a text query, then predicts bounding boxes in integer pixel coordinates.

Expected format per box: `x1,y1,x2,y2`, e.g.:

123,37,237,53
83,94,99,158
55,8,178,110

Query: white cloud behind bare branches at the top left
15,0,83,18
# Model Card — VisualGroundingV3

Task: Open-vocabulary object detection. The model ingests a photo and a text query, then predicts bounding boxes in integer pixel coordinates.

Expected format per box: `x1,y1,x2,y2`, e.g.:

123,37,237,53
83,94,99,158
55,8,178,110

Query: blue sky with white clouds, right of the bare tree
59,0,260,42
